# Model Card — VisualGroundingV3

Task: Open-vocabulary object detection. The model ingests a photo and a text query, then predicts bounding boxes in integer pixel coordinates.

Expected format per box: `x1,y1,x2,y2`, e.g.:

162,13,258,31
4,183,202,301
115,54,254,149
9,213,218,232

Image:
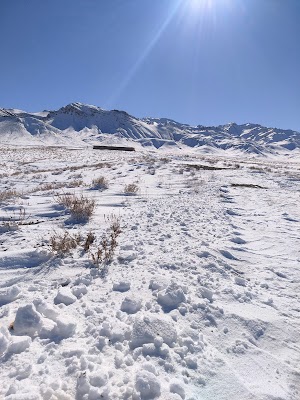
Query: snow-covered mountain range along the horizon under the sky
0,103,300,154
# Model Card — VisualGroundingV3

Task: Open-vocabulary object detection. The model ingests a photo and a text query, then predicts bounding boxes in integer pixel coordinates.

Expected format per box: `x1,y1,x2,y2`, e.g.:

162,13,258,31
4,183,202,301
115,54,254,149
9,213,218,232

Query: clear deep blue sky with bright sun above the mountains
0,0,300,131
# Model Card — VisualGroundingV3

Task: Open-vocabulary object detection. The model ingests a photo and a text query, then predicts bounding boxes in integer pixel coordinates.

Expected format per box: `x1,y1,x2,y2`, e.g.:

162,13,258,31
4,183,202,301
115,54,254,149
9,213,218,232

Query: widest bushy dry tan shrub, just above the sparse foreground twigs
56,193,96,221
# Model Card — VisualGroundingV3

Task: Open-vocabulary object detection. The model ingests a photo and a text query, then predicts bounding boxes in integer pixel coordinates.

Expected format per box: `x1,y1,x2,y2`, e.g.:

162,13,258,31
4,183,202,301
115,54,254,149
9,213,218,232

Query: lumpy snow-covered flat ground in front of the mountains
0,147,300,400
